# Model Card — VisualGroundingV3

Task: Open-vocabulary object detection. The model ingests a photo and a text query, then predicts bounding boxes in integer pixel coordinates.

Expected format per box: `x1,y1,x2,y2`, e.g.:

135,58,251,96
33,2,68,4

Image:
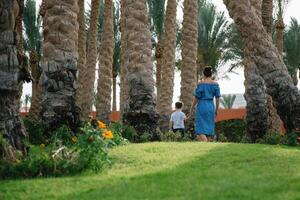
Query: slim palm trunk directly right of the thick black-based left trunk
76,0,87,117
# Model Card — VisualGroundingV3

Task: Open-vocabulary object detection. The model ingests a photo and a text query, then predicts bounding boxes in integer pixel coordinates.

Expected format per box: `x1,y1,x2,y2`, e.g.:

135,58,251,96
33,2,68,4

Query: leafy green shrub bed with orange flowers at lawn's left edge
0,123,126,178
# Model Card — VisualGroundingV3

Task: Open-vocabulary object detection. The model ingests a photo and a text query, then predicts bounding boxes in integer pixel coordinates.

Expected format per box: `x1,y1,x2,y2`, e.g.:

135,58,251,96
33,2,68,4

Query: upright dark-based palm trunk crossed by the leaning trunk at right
244,0,280,142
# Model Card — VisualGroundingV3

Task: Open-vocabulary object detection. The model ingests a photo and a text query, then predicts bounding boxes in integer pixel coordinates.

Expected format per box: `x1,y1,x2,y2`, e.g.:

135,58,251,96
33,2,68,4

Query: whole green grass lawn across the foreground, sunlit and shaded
0,143,300,200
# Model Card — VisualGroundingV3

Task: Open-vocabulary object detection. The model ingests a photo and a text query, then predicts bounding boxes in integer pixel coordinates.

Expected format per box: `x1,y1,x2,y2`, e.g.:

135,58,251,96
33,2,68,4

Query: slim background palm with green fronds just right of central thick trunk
148,0,166,101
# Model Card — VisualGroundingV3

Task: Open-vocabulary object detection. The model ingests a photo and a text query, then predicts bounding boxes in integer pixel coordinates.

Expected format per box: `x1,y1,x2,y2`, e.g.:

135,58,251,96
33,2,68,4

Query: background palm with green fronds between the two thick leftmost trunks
24,0,42,120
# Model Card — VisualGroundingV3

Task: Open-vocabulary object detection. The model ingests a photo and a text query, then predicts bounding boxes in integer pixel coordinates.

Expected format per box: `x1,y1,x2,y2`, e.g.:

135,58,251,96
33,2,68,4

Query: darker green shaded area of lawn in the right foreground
60,145,300,200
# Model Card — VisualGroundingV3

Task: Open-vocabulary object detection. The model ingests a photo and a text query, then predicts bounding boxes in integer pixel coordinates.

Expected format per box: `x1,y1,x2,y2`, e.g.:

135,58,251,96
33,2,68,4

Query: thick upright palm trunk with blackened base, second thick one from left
42,0,80,130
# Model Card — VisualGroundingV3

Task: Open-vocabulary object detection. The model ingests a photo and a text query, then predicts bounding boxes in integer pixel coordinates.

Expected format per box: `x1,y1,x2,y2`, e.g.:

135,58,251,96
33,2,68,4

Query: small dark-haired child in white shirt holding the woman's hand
169,101,187,137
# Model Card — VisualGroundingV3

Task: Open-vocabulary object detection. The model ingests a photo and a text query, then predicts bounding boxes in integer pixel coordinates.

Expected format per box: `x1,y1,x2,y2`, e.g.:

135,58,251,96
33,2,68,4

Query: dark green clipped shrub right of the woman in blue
216,120,246,142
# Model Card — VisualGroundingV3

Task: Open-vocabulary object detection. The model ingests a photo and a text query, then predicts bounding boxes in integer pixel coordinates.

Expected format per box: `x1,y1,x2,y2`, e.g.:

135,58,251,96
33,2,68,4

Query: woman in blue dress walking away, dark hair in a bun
189,67,221,142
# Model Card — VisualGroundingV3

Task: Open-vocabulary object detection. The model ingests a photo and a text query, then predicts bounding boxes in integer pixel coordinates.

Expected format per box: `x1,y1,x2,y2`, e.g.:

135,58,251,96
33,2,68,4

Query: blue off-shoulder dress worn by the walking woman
195,83,221,136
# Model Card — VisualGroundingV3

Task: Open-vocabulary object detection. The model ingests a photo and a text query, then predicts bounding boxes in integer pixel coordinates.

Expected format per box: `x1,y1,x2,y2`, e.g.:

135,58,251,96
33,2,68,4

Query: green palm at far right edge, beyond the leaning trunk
284,18,300,85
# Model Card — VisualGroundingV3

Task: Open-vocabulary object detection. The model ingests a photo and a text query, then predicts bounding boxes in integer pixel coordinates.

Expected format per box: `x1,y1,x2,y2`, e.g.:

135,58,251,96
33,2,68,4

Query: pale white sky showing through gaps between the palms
23,0,300,105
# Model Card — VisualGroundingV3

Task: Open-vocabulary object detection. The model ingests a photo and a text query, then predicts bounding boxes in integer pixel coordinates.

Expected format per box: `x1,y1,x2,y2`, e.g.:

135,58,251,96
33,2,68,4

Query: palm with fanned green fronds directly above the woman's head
197,3,234,78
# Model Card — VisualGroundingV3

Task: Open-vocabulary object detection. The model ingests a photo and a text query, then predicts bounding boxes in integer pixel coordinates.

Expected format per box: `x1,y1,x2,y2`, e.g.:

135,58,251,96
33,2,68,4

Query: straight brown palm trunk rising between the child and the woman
180,0,198,115
